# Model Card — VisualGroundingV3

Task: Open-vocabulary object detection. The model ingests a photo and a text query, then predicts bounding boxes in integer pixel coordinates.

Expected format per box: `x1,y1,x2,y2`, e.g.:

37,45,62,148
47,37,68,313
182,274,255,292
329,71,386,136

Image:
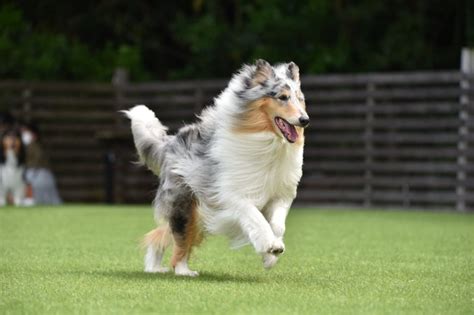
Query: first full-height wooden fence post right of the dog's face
364,82,375,207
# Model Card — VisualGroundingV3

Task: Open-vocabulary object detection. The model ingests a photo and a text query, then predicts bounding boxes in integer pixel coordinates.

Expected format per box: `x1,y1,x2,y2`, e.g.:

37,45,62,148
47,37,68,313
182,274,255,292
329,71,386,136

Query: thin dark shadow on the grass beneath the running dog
73,270,263,283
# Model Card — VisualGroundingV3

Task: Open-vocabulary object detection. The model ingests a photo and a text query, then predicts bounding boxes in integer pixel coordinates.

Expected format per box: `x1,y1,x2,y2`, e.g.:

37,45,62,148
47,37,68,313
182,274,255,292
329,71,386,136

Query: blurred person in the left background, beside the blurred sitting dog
21,124,62,205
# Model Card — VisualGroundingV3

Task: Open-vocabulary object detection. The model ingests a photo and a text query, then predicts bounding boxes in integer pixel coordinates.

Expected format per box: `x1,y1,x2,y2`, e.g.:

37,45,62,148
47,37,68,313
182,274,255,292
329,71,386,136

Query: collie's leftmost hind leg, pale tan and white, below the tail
144,223,172,273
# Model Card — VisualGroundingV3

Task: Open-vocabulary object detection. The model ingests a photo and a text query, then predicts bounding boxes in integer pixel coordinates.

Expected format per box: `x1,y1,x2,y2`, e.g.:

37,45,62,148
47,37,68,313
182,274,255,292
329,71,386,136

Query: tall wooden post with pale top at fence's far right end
456,48,474,212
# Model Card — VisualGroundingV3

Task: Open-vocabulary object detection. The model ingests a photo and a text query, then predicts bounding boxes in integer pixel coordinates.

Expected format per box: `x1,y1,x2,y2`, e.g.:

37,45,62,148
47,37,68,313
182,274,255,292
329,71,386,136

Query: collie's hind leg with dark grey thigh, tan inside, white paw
170,194,202,277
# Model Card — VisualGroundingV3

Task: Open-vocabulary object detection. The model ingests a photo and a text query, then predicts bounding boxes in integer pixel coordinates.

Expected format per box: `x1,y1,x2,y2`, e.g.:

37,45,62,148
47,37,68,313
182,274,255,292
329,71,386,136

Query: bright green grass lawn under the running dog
0,206,474,314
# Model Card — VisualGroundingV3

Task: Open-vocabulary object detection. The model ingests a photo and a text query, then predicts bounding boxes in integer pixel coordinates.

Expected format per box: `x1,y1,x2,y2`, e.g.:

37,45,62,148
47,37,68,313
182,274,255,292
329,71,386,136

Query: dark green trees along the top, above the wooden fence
0,0,474,81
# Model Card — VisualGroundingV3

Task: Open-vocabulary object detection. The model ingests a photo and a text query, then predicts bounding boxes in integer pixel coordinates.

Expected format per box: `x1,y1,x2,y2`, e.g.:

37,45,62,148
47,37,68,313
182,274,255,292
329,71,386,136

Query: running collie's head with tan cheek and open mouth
237,59,309,143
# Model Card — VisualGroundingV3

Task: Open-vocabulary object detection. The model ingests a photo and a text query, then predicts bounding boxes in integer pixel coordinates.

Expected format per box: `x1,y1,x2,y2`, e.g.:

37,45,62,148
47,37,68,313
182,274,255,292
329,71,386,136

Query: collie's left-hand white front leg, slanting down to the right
232,201,284,254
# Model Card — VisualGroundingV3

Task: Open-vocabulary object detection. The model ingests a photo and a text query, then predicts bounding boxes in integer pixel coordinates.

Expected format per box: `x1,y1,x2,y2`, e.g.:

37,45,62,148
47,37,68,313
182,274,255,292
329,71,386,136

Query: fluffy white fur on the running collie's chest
211,131,303,209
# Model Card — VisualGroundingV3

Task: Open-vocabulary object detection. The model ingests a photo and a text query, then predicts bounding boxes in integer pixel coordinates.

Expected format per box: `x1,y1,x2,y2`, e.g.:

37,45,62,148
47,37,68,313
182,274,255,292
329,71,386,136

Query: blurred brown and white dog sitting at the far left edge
0,129,26,206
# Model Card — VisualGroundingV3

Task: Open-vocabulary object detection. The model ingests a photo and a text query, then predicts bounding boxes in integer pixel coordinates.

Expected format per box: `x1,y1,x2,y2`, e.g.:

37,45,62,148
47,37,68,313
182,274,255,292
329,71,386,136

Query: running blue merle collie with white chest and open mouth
124,60,309,276
